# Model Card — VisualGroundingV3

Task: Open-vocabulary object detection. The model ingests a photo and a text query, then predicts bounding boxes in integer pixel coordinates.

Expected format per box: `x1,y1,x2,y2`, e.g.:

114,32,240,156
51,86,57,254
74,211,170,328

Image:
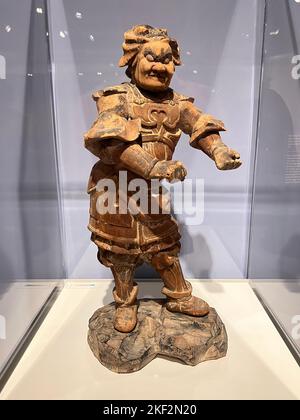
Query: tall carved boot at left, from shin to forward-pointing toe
111,265,138,333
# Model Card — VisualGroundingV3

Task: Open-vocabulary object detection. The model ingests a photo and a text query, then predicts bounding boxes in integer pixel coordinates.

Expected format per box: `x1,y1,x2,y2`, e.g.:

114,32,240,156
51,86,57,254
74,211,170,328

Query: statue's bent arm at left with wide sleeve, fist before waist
84,94,186,180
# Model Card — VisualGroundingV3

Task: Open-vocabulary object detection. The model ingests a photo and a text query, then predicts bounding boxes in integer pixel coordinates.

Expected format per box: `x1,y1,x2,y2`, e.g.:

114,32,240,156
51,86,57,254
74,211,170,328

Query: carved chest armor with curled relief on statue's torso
129,87,181,160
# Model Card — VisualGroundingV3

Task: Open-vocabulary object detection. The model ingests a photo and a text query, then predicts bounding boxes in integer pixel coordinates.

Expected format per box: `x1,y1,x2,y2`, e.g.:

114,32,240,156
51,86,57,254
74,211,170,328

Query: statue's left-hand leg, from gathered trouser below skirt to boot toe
98,250,138,333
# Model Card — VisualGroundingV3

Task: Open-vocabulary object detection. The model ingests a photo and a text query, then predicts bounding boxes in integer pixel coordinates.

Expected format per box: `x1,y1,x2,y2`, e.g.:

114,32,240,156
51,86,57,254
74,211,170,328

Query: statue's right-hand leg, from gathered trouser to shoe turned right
151,246,209,316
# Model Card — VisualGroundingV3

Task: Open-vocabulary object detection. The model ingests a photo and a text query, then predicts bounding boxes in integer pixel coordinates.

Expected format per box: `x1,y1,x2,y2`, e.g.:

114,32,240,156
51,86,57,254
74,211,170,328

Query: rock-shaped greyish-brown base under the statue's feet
88,299,227,373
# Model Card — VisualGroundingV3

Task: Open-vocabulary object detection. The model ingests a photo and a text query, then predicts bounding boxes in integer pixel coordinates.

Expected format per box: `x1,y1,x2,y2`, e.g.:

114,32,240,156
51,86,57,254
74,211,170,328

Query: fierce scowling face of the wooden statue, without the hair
132,40,175,92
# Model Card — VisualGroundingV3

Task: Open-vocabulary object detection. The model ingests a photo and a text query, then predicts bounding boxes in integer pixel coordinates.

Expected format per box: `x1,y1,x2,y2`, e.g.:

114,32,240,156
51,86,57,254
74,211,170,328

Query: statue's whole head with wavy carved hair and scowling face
119,25,181,92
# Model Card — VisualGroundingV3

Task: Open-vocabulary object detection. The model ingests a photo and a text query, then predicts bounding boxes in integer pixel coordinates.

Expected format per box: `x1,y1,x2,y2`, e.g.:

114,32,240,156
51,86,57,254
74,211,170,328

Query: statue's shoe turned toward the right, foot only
166,296,209,316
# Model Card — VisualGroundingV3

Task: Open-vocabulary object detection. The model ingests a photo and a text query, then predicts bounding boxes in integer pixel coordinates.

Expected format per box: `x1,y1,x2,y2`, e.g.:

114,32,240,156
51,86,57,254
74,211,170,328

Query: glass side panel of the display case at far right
247,0,300,356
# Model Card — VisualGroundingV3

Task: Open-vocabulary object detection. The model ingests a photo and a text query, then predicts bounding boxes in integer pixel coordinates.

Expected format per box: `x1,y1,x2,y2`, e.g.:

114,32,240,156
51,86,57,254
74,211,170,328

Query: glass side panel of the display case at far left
0,0,65,384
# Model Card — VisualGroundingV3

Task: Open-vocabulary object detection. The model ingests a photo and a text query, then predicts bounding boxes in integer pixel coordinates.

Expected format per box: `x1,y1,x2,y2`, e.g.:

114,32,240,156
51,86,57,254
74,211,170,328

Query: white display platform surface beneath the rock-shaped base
0,281,300,400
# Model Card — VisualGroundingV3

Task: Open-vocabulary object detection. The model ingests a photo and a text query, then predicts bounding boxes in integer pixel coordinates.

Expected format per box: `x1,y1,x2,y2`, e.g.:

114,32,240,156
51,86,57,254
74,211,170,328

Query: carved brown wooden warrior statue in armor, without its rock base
85,25,241,340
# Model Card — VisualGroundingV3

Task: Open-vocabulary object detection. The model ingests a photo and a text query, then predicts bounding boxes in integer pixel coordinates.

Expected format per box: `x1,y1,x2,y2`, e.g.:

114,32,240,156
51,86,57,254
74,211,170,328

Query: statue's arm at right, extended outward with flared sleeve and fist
180,99,242,170
